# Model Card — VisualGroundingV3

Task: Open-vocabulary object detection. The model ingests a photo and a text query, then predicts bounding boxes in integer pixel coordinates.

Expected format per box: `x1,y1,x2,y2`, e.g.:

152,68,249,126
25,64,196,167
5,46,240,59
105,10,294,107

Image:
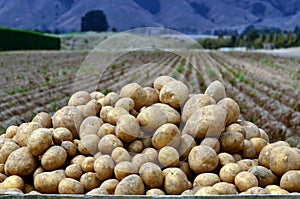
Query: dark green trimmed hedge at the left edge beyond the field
0,28,60,50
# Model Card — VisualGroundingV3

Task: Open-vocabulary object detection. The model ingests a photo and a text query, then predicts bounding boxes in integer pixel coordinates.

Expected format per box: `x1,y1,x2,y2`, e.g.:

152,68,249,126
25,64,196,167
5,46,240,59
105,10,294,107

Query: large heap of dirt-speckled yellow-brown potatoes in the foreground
0,76,300,195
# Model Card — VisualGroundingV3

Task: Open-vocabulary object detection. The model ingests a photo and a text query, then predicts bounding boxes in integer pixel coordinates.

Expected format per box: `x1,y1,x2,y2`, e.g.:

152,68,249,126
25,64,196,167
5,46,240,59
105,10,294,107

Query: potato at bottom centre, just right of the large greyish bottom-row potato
139,162,163,189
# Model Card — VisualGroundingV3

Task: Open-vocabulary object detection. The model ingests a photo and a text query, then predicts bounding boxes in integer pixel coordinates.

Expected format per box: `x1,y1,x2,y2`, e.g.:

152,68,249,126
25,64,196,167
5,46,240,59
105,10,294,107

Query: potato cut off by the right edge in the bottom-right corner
280,170,300,192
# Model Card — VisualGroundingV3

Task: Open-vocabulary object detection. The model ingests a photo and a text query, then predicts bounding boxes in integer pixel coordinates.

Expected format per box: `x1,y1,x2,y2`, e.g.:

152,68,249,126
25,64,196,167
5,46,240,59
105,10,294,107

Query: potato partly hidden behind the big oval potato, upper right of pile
181,94,216,122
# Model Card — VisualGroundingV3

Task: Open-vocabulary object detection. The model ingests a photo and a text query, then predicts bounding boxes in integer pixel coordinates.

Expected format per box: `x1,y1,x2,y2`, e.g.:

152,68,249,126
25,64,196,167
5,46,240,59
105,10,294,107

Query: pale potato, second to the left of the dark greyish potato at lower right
219,163,242,183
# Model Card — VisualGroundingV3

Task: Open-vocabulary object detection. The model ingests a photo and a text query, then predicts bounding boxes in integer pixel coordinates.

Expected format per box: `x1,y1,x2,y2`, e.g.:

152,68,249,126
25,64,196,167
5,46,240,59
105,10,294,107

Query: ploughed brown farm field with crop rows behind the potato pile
0,50,300,147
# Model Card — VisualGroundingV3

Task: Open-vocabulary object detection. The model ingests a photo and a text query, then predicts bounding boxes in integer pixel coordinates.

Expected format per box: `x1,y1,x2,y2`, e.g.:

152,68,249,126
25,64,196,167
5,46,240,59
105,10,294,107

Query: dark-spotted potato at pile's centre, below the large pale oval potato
152,123,180,149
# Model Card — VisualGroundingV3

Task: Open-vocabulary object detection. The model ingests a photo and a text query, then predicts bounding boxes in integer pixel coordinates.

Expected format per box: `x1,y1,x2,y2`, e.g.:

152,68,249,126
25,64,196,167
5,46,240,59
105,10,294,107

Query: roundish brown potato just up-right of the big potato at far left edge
27,128,52,156
